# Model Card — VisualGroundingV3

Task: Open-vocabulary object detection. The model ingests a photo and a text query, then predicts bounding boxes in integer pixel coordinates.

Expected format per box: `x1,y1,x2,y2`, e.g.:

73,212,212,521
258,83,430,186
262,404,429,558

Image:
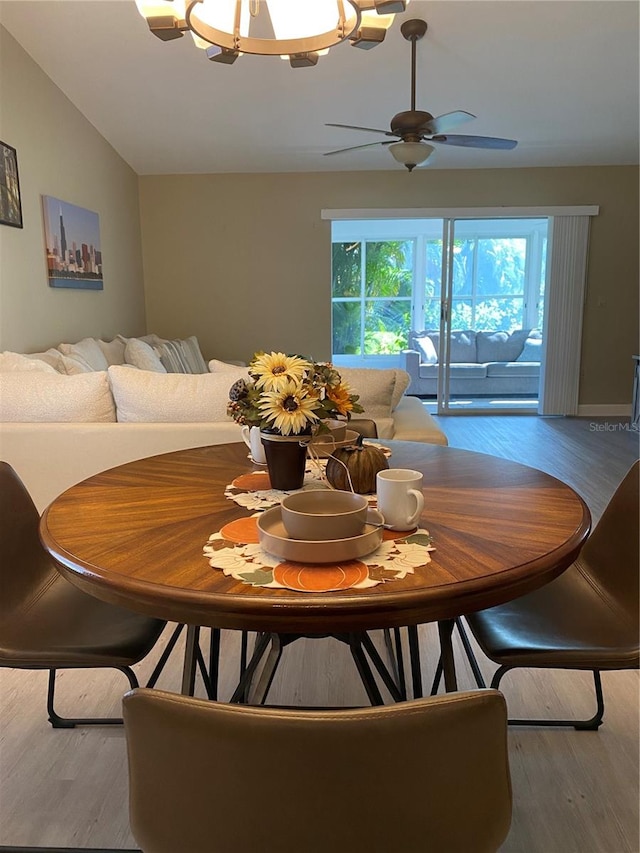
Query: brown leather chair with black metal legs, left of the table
0,462,182,728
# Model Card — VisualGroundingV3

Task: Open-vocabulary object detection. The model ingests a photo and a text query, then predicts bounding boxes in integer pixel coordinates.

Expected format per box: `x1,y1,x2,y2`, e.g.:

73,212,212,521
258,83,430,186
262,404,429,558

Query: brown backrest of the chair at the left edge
0,462,55,619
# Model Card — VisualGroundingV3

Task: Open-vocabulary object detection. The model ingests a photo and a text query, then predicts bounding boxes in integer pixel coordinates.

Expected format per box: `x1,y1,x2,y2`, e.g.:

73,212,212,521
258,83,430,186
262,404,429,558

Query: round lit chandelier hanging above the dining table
136,0,409,68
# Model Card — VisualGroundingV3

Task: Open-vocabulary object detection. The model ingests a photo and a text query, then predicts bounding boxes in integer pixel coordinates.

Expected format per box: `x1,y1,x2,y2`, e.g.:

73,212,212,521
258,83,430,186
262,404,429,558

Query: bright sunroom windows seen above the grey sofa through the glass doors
332,218,547,361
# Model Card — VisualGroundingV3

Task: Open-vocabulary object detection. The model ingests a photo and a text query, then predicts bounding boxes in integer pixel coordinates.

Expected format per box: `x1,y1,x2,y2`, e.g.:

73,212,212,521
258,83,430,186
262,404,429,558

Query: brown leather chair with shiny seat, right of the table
463,462,640,729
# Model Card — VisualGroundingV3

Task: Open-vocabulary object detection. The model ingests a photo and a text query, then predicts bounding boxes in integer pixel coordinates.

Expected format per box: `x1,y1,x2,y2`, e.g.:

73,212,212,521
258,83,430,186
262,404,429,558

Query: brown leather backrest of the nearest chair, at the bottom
124,689,511,853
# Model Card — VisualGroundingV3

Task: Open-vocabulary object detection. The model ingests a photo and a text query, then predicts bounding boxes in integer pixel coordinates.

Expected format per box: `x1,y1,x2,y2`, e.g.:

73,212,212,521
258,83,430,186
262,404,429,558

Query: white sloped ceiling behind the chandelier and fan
0,0,639,174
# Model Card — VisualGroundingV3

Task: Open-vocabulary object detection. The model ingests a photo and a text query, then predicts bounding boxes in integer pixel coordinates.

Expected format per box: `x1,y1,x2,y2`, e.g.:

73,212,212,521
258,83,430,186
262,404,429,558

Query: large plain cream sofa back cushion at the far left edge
0,370,116,423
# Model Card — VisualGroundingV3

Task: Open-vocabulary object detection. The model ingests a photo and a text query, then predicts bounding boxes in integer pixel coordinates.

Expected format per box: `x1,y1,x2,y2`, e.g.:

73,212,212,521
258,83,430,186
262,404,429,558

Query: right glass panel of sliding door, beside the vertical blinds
438,218,547,413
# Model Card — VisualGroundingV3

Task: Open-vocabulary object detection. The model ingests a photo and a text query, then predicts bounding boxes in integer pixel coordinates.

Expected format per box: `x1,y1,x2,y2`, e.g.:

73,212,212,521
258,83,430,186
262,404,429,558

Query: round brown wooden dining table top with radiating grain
40,441,591,634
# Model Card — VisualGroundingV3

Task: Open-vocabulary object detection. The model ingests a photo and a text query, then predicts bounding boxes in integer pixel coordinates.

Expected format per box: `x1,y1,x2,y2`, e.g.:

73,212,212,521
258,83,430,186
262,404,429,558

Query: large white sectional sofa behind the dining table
0,332,447,511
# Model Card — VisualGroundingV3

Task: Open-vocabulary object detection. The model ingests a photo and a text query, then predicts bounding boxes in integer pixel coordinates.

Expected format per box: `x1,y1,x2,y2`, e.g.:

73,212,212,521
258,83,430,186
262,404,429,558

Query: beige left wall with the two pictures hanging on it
0,27,145,351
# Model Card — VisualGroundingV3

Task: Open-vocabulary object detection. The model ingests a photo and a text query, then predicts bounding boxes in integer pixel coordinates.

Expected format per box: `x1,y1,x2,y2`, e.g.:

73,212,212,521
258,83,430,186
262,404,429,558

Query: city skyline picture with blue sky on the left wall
42,195,104,290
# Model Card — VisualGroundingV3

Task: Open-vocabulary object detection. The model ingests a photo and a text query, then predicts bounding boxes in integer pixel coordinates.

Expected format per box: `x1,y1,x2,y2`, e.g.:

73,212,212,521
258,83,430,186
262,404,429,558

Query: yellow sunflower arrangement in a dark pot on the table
227,352,363,491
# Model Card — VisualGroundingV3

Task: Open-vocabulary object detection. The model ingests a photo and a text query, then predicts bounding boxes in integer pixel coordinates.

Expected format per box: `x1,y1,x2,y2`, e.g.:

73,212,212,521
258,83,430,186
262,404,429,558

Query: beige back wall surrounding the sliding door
140,167,639,405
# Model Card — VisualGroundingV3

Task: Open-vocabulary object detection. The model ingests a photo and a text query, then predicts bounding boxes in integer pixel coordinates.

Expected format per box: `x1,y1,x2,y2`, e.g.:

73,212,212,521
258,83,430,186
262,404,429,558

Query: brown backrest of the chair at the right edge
577,461,640,626
